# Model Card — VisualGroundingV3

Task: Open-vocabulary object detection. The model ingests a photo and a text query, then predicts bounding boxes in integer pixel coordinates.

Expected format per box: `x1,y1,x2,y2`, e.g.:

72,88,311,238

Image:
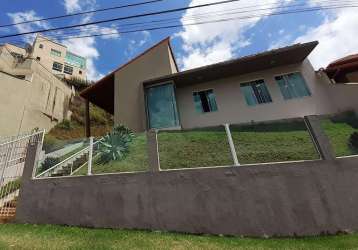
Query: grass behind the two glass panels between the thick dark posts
159,121,319,169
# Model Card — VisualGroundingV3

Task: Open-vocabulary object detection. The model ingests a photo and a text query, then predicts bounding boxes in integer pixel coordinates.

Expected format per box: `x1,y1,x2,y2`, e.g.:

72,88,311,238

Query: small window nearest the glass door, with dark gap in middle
193,89,218,113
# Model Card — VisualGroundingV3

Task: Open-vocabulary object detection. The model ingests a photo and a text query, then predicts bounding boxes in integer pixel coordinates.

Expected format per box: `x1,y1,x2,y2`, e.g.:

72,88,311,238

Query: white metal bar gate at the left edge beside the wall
0,131,45,222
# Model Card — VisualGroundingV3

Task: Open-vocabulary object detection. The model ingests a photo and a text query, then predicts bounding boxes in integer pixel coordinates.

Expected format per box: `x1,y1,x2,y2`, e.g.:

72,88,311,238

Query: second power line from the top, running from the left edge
0,0,240,38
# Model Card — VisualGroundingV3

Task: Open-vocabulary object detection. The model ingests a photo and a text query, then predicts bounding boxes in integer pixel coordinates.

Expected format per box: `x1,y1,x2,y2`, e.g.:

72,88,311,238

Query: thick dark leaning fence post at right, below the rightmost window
304,115,336,160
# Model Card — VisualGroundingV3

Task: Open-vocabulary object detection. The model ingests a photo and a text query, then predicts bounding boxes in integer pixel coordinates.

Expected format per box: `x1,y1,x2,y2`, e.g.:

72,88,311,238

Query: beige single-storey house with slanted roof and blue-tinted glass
81,38,358,134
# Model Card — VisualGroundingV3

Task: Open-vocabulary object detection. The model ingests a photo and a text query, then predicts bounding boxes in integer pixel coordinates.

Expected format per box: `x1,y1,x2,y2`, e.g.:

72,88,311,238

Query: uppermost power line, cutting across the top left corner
0,0,164,28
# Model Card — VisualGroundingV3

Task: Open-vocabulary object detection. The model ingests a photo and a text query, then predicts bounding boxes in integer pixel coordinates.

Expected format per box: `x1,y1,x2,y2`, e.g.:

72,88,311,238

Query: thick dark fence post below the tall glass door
147,129,160,172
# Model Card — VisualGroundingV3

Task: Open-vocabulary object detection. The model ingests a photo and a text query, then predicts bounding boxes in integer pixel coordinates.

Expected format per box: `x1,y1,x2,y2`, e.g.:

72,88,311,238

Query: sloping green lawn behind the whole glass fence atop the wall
73,115,358,175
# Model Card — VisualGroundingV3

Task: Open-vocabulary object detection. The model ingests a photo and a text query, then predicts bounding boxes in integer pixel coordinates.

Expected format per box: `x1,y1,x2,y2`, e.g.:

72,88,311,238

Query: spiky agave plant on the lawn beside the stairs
99,125,134,163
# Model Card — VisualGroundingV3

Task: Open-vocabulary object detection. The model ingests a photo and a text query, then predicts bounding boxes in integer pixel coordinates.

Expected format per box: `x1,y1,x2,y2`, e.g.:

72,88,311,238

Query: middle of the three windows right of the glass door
240,80,272,106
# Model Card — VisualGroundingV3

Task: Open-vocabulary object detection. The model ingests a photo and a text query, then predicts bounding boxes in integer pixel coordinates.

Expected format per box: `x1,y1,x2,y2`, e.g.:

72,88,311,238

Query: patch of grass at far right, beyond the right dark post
321,118,358,156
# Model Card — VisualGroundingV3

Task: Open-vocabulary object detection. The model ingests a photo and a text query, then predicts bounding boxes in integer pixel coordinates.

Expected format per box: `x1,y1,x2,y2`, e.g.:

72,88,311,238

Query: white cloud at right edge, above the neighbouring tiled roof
295,8,358,69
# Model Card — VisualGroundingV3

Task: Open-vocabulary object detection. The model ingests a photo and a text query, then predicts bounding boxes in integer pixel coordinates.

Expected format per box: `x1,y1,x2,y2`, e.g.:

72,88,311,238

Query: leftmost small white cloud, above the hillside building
7,10,51,43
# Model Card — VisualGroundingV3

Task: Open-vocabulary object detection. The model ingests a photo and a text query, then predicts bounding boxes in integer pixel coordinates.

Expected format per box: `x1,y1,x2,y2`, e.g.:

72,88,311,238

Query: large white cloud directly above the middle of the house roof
177,0,293,69
